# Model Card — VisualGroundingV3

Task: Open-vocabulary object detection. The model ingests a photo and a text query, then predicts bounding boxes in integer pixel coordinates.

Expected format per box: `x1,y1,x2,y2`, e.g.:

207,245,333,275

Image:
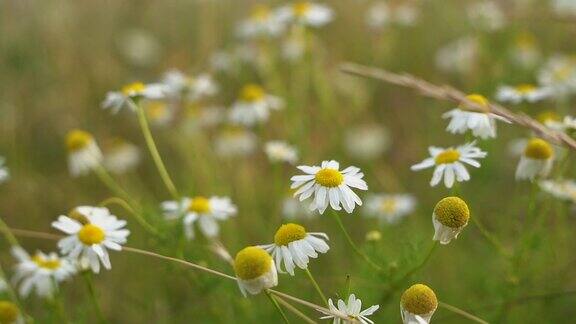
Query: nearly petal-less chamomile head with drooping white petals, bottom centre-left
234,246,278,297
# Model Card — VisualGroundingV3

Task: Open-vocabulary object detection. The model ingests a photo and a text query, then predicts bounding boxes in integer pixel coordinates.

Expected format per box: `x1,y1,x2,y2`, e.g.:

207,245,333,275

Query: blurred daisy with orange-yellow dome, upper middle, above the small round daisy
230,84,284,126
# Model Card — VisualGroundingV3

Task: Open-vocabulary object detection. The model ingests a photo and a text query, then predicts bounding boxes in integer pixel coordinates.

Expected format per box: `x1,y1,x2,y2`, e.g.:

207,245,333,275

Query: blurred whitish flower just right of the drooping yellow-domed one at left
104,137,141,174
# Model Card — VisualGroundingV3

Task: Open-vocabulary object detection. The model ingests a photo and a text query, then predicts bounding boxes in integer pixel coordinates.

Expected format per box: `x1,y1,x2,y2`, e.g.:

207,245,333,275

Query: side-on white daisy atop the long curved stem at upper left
102,82,165,113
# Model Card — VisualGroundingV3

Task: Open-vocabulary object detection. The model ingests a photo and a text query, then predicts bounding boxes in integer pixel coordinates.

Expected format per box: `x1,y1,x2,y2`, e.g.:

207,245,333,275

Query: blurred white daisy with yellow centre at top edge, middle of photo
277,1,334,27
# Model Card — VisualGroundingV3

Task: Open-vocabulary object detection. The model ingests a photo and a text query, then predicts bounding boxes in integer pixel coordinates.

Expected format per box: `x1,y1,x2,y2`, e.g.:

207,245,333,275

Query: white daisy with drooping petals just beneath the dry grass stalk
442,94,508,139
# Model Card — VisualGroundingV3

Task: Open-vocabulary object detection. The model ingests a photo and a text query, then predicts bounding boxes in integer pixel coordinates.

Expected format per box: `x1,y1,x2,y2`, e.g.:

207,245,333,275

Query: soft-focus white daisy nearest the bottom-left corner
11,246,76,298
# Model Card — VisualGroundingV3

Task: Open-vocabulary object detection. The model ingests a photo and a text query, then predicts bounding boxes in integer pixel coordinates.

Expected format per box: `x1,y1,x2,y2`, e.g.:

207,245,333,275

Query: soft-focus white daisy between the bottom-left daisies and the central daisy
162,196,237,239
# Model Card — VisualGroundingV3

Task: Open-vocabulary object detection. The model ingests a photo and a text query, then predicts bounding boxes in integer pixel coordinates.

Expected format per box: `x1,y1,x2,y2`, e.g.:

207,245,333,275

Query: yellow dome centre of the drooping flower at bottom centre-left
234,246,272,280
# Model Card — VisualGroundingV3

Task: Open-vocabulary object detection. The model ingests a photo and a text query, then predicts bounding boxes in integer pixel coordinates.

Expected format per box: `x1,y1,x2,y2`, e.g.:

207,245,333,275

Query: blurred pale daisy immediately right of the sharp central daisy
364,194,416,224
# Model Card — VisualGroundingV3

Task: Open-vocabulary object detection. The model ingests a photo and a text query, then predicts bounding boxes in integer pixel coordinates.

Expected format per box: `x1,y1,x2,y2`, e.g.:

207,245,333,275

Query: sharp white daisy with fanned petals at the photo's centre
290,160,368,214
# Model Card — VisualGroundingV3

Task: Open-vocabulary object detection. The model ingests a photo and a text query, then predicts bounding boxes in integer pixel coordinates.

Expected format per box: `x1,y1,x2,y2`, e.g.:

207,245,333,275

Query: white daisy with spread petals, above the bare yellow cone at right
411,142,488,188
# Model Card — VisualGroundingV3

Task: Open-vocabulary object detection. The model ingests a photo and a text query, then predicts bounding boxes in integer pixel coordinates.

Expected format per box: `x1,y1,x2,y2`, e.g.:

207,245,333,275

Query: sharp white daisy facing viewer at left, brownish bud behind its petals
52,206,130,273
